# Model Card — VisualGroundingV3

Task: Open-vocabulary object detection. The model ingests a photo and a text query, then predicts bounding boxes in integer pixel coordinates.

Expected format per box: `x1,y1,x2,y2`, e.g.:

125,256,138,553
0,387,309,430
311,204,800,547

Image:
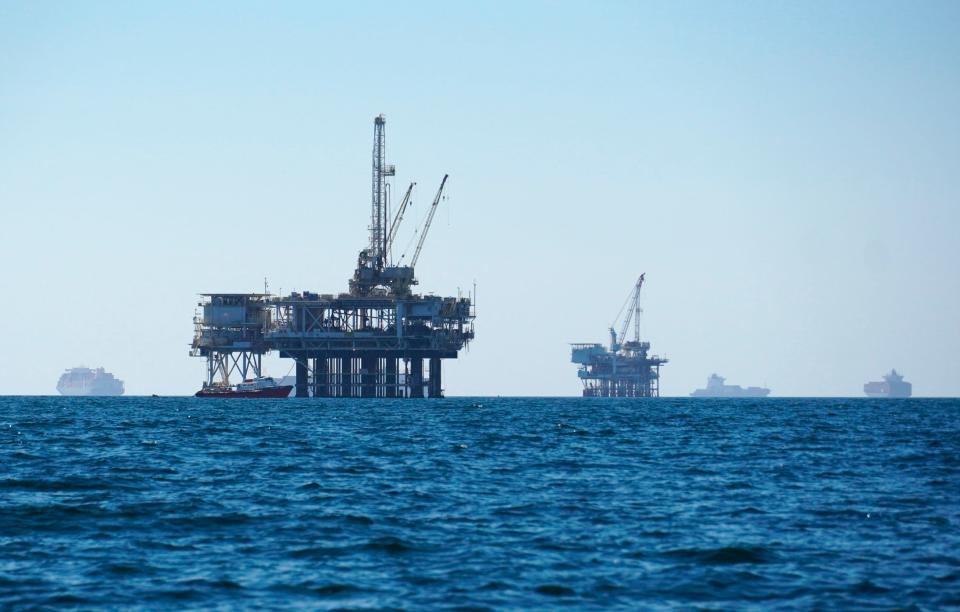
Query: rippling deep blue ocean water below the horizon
0,398,960,609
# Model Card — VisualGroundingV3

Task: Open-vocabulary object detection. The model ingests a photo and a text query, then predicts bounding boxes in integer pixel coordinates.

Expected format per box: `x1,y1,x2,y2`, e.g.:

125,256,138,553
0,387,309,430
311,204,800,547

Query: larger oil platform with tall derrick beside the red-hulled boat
191,115,476,398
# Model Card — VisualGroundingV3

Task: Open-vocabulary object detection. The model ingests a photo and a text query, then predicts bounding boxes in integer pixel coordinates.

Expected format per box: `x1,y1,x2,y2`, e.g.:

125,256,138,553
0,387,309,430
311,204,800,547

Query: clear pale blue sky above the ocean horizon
0,0,960,396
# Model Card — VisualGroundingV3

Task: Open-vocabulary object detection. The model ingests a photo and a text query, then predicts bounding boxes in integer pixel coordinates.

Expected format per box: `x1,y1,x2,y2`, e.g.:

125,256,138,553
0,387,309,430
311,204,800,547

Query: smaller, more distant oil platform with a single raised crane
570,274,667,397
